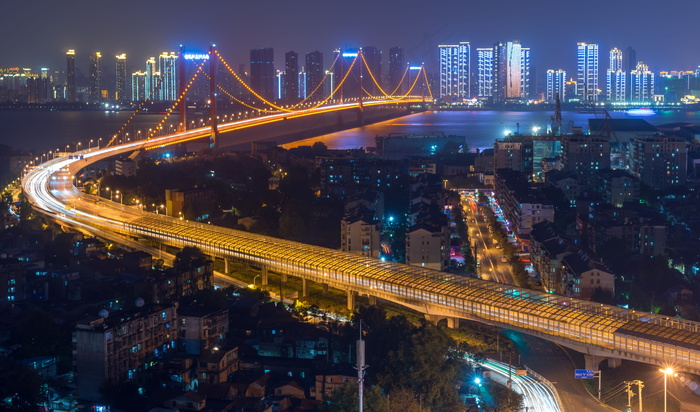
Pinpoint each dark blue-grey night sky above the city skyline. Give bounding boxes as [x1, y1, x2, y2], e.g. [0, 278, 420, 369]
[0, 0, 700, 77]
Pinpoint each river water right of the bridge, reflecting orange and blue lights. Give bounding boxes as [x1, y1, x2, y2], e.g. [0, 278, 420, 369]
[283, 111, 700, 149]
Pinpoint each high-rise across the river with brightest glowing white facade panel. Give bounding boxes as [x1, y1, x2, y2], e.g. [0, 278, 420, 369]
[492, 41, 530, 102]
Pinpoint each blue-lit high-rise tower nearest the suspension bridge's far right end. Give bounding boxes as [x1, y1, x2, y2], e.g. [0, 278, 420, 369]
[438, 42, 471, 102]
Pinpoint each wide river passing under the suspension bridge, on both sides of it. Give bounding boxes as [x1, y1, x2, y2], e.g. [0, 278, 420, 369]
[0, 111, 700, 153]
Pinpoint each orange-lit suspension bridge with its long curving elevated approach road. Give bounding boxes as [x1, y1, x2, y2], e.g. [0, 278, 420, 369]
[17, 47, 700, 374]
